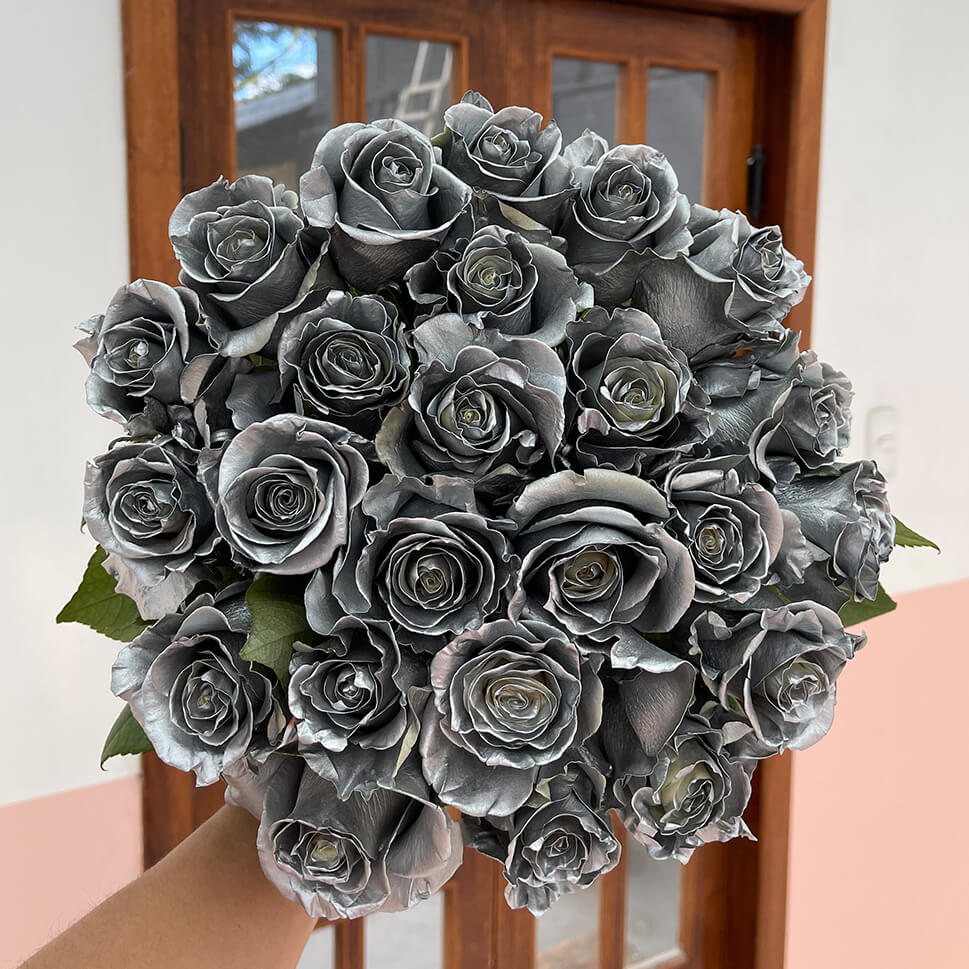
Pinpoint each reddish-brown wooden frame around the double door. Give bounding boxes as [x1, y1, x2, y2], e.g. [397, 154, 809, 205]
[121, 0, 827, 969]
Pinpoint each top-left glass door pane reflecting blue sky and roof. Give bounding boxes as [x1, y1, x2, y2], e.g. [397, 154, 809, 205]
[232, 20, 336, 189]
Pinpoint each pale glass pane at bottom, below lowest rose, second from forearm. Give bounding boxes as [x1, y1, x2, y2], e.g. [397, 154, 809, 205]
[364, 892, 444, 969]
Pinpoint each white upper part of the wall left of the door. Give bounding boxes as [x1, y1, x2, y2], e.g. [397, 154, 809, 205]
[0, 0, 137, 805]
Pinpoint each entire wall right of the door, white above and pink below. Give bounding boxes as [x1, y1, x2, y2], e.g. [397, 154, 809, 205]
[785, 0, 969, 969]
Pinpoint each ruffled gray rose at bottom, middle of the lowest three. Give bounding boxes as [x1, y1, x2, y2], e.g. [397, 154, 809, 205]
[475, 763, 622, 915]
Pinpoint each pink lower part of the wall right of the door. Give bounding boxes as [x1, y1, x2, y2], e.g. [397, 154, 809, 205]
[785, 581, 969, 969]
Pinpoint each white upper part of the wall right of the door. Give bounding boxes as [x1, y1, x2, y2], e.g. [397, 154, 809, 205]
[813, 0, 969, 592]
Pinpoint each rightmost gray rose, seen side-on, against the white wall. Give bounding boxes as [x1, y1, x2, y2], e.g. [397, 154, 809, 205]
[775, 461, 895, 599]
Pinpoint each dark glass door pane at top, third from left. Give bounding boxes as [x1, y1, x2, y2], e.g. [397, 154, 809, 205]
[552, 57, 619, 145]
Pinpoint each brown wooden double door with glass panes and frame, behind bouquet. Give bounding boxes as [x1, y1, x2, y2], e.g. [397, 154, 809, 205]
[124, 0, 825, 969]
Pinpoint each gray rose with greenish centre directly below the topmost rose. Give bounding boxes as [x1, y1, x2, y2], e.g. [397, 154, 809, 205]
[405, 225, 592, 347]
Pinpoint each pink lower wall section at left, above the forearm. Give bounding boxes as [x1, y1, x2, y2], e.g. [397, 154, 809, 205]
[0, 777, 141, 969]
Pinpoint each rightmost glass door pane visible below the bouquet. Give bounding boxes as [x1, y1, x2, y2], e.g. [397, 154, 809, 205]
[626, 838, 682, 969]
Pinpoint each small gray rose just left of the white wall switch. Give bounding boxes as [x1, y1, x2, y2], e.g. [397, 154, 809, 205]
[767, 350, 854, 478]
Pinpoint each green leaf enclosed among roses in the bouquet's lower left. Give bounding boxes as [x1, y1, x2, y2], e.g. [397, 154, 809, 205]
[239, 575, 313, 686]
